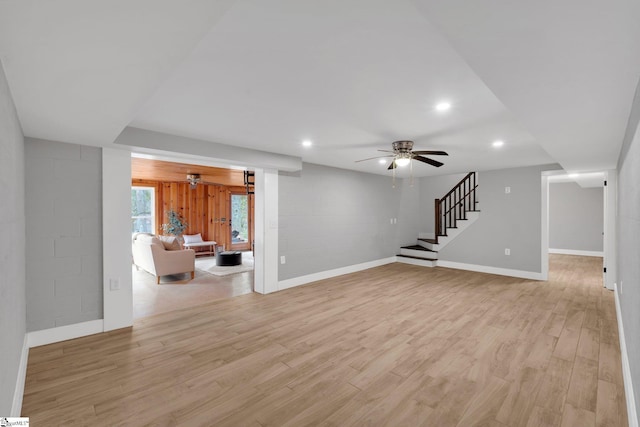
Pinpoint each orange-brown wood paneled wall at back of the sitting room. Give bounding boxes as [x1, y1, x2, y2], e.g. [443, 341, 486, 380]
[131, 179, 255, 250]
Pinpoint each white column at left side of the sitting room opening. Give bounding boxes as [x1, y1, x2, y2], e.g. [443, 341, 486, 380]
[102, 148, 133, 331]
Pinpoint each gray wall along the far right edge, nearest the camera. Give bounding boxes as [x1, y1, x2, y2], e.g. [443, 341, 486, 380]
[617, 88, 640, 421]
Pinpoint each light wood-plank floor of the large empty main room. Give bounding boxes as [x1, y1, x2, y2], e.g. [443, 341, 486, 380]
[22, 255, 627, 427]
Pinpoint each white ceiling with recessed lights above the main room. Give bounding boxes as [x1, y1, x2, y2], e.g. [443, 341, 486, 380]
[0, 0, 640, 176]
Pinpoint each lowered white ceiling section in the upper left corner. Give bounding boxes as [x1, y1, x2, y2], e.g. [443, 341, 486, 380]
[0, 0, 232, 145]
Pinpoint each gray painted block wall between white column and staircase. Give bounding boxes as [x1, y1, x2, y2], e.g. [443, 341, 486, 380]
[278, 163, 401, 280]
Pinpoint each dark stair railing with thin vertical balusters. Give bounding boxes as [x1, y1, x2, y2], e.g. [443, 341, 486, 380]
[435, 172, 478, 243]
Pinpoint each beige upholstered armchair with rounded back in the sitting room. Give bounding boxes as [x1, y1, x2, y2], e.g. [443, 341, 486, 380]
[132, 233, 196, 284]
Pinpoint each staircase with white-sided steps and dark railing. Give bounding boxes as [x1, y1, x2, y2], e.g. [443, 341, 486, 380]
[397, 172, 480, 267]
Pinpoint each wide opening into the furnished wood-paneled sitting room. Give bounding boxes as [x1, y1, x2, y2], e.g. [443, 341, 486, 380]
[131, 154, 254, 319]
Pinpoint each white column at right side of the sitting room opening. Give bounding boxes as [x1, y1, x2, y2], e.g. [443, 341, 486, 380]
[254, 169, 278, 294]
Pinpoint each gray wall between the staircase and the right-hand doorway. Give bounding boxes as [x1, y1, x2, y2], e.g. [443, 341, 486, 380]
[438, 165, 557, 273]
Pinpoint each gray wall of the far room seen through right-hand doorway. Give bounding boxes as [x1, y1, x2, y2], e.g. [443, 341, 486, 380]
[549, 182, 604, 252]
